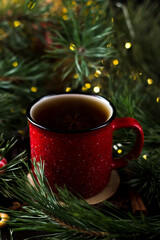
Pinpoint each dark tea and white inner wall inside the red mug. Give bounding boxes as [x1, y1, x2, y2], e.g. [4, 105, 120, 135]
[31, 94, 111, 132]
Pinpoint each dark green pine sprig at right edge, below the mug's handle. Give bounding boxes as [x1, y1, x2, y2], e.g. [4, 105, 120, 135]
[127, 151, 160, 208]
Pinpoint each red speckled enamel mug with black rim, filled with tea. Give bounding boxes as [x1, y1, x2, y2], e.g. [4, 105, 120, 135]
[27, 93, 144, 198]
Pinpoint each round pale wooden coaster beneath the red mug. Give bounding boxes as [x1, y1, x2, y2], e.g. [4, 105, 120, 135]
[27, 170, 120, 205]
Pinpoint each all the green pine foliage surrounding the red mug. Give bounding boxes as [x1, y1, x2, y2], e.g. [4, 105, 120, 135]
[0, 0, 160, 240]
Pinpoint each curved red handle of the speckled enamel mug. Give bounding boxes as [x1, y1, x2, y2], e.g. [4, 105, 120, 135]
[111, 117, 144, 169]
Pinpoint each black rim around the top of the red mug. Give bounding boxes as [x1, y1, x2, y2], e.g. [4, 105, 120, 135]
[26, 93, 116, 134]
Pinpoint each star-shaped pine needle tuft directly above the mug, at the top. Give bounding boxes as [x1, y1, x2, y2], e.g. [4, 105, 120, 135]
[47, 1, 113, 88]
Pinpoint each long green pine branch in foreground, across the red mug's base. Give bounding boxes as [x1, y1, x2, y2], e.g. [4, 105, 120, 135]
[1, 159, 160, 239]
